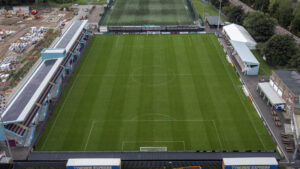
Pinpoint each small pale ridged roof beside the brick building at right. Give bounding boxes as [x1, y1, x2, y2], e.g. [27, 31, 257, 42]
[258, 82, 285, 105]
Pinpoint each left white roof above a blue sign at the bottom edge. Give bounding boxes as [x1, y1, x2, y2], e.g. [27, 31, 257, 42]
[67, 158, 121, 167]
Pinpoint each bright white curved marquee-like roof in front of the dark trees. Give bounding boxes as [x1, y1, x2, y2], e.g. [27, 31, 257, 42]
[223, 24, 257, 46]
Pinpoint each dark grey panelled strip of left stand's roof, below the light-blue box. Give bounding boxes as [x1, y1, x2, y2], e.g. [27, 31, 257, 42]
[3, 59, 56, 121]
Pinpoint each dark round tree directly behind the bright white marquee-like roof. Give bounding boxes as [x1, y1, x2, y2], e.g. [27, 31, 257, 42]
[226, 6, 245, 25]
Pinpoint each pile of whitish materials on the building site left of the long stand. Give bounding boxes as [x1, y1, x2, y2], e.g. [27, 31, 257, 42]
[9, 27, 47, 53]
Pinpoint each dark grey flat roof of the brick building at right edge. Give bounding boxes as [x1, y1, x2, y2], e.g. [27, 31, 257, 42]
[274, 70, 300, 95]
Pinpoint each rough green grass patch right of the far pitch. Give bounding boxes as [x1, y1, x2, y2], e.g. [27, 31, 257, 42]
[192, 0, 226, 22]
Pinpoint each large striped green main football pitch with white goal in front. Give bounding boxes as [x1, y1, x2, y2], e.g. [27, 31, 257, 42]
[37, 34, 275, 151]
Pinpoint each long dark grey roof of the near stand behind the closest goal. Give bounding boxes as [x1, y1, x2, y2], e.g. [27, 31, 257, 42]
[28, 151, 278, 162]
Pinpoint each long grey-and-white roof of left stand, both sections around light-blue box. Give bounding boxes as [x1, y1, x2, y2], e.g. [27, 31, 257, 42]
[1, 21, 87, 123]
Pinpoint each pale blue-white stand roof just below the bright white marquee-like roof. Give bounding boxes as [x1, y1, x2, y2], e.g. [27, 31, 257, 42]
[230, 40, 259, 65]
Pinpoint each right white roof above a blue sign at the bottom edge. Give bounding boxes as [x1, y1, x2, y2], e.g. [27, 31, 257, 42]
[223, 157, 278, 165]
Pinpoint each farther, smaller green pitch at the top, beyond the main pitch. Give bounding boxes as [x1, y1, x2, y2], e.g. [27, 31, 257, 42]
[101, 0, 193, 26]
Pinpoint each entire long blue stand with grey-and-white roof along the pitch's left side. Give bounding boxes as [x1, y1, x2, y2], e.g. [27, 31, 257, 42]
[1, 21, 90, 146]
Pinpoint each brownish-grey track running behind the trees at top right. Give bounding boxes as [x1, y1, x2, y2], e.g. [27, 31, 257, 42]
[229, 0, 300, 45]
